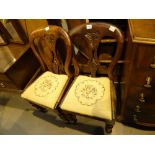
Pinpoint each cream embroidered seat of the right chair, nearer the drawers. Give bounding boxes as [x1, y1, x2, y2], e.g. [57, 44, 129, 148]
[60, 75, 112, 120]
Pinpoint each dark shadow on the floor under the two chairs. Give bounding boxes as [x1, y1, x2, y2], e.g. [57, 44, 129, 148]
[33, 111, 104, 135]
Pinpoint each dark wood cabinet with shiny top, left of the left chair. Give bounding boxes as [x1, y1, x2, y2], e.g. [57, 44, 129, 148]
[0, 44, 40, 91]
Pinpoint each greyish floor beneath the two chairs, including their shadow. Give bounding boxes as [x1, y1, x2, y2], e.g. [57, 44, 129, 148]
[0, 92, 155, 135]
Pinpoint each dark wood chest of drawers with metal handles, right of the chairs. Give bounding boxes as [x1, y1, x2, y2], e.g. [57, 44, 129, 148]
[121, 19, 155, 127]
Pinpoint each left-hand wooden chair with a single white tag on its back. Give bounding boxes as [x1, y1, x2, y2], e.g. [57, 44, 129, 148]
[21, 26, 73, 121]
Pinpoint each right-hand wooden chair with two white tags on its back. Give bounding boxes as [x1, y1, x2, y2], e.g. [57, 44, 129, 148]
[60, 23, 124, 133]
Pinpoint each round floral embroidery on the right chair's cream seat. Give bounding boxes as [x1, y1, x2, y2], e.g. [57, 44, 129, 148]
[75, 80, 105, 106]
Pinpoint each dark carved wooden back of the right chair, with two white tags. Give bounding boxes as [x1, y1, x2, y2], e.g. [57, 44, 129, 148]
[69, 22, 124, 79]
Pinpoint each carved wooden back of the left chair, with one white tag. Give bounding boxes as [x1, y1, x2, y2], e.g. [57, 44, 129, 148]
[30, 25, 72, 77]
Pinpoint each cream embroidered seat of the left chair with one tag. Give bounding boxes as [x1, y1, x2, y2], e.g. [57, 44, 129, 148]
[21, 71, 68, 109]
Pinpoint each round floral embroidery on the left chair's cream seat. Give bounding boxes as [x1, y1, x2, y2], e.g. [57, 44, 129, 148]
[34, 75, 59, 97]
